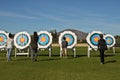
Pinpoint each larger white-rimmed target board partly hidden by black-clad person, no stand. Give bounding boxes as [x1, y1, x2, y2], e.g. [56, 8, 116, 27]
[86, 31, 103, 48]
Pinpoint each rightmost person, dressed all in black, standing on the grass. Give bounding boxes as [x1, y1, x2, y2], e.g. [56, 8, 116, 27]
[98, 34, 107, 64]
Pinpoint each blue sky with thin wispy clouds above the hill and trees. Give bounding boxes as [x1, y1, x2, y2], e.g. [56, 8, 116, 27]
[0, 0, 120, 35]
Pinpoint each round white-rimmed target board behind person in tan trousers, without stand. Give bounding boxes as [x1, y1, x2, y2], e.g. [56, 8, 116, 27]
[59, 31, 77, 48]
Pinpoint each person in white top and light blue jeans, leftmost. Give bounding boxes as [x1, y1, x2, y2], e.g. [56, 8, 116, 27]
[6, 33, 13, 61]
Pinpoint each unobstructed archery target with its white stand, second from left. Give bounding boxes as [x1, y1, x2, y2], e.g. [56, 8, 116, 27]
[14, 31, 31, 57]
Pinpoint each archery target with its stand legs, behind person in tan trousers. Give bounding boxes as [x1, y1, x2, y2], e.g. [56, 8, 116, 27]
[59, 31, 77, 57]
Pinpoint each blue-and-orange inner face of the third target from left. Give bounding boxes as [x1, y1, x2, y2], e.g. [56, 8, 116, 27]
[38, 33, 50, 46]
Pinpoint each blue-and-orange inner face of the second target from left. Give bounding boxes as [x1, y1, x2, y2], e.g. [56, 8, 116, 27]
[16, 34, 29, 46]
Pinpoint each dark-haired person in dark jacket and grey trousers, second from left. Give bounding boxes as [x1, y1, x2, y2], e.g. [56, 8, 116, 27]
[30, 32, 38, 61]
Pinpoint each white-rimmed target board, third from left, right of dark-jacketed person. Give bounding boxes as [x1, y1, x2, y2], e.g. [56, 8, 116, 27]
[38, 31, 52, 48]
